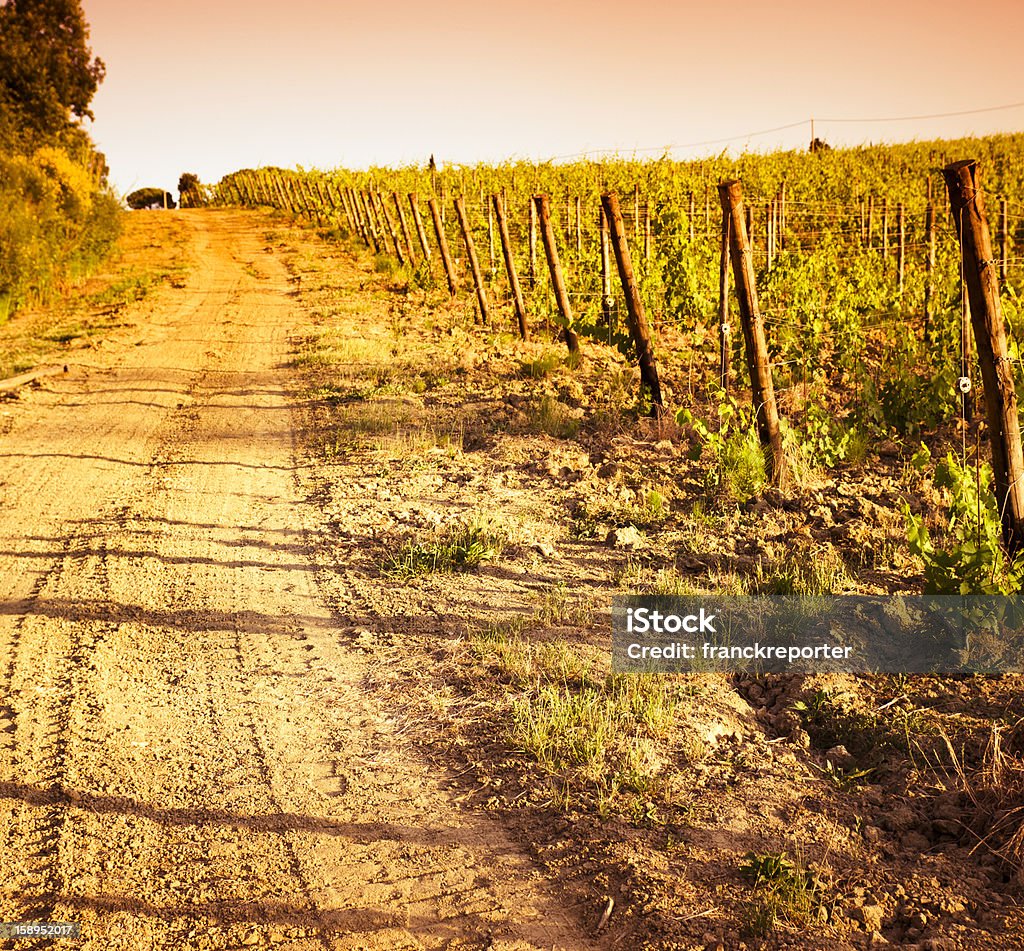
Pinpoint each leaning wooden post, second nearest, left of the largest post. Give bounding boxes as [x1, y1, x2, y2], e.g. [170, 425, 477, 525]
[718, 180, 788, 486]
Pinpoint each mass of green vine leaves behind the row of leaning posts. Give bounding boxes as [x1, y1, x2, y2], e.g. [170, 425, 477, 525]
[216, 136, 1024, 446]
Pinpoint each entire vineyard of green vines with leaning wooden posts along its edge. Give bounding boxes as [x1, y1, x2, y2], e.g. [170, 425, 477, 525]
[213, 136, 1024, 594]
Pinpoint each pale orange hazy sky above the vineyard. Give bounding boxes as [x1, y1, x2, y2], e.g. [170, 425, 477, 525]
[82, 0, 1024, 193]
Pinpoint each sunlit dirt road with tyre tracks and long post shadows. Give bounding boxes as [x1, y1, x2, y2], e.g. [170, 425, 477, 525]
[0, 212, 592, 949]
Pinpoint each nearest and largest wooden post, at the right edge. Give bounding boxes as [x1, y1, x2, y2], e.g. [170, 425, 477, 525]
[942, 159, 1024, 554]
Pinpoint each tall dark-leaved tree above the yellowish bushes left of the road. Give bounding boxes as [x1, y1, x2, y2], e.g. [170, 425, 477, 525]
[0, 0, 105, 147]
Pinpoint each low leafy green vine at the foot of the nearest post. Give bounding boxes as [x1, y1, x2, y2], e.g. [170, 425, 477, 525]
[904, 452, 1024, 595]
